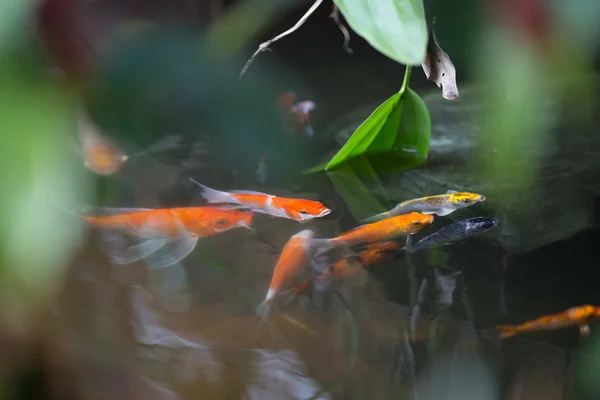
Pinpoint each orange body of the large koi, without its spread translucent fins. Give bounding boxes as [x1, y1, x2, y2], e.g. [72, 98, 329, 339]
[82, 207, 253, 238]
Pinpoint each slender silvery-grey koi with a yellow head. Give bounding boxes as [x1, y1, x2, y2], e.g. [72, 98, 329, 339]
[362, 190, 485, 223]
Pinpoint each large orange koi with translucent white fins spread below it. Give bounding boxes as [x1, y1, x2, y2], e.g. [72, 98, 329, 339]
[81, 207, 253, 268]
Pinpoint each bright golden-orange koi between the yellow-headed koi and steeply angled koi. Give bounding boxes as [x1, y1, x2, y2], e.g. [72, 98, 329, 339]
[311, 212, 433, 256]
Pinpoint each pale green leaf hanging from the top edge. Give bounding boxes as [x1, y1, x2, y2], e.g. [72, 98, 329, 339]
[334, 0, 428, 65]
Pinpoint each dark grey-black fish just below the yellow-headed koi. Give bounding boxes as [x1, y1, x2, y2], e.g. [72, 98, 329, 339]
[404, 217, 498, 253]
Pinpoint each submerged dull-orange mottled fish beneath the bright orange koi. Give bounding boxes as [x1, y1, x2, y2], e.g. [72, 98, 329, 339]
[291, 242, 400, 293]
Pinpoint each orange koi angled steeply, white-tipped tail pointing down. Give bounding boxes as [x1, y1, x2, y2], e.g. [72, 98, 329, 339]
[256, 229, 314, 318]
